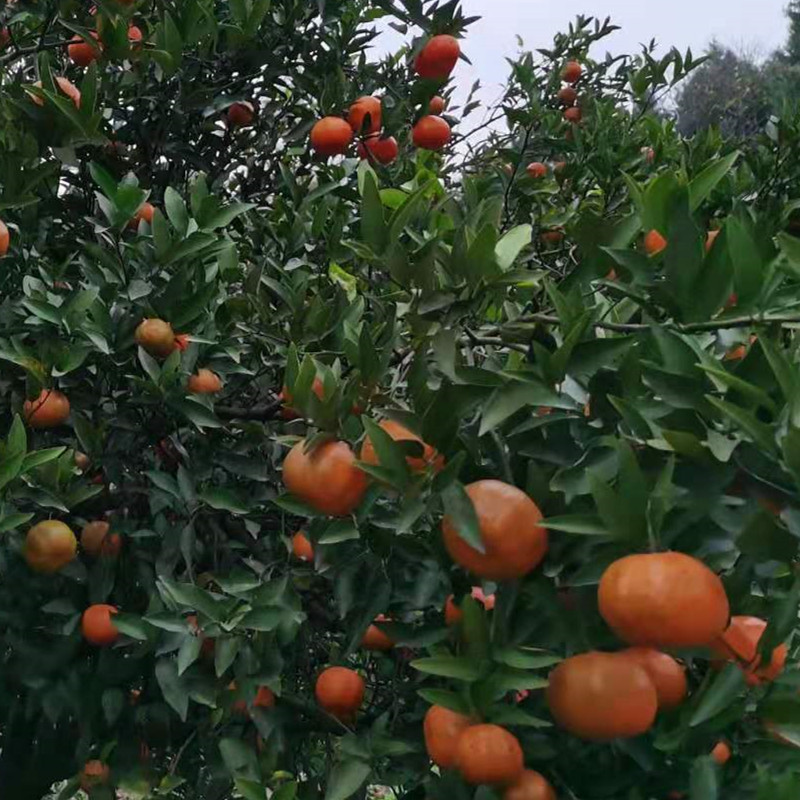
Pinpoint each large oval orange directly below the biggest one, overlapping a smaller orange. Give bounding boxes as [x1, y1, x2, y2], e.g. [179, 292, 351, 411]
[547, 652, 658, 741]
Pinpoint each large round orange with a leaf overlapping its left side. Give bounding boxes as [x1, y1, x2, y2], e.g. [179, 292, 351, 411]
[442, 480, 547, 581]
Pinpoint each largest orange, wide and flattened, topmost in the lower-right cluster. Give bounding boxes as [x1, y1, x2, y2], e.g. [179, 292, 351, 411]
[598, 553, 730, 648]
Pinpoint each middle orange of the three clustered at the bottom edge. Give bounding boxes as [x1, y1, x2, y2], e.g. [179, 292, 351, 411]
[456, 724, 525, 786]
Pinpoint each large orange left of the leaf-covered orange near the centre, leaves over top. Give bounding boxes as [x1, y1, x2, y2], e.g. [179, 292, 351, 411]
[283, 440, 367, 517]
